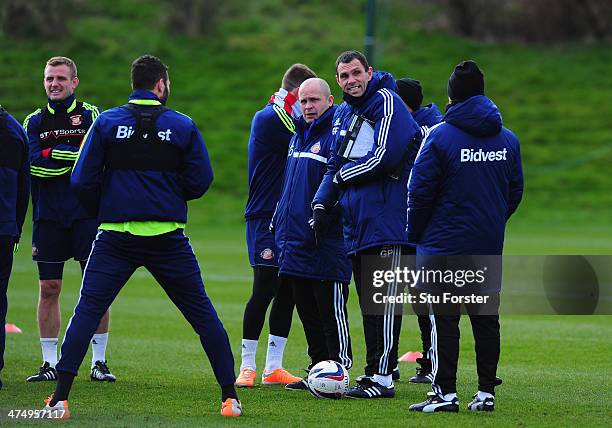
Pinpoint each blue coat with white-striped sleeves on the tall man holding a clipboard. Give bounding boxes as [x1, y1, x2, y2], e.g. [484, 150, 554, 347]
[313, 72, 420, 255]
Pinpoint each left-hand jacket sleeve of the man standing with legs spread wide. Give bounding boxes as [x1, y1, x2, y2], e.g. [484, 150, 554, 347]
[70, 120, 104, 216]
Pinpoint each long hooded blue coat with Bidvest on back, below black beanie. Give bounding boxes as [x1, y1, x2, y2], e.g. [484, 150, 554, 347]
[407, 95, 523, 255]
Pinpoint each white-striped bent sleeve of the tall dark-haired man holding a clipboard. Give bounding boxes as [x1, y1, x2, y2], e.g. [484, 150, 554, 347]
[340, 89, 419, 185]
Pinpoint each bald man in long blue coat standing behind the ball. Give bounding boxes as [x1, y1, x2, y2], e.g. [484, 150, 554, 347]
[272, 78, 353, 389]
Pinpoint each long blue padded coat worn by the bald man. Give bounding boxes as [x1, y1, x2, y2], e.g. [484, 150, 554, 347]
[272, 106, 351, 283]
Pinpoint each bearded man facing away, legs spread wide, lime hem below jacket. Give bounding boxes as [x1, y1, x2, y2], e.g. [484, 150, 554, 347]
[45, 55, 242, 417]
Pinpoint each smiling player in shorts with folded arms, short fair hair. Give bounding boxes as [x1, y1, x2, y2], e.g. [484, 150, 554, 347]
[23, 56, 115, 382]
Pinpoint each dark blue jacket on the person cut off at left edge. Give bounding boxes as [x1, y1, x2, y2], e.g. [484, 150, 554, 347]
[0, 107, 30, 241]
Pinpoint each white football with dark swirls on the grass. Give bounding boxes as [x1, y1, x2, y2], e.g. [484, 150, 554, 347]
[308, 360, 349, 400]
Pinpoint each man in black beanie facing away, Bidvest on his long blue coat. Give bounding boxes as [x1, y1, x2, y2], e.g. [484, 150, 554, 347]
[407, 61, 523, 413]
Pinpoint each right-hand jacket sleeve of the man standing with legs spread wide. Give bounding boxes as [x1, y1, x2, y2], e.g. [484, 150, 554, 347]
[180, 122, 213, 201]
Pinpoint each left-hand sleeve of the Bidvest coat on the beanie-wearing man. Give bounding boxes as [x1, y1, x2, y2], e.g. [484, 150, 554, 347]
[406, 135, 442, 244]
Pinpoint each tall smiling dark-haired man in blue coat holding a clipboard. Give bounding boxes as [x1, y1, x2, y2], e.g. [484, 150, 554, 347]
[313, 51, 420, 399]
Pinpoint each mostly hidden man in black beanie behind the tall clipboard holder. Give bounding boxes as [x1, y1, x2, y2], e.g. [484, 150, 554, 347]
[394, 77, 442, 383]
